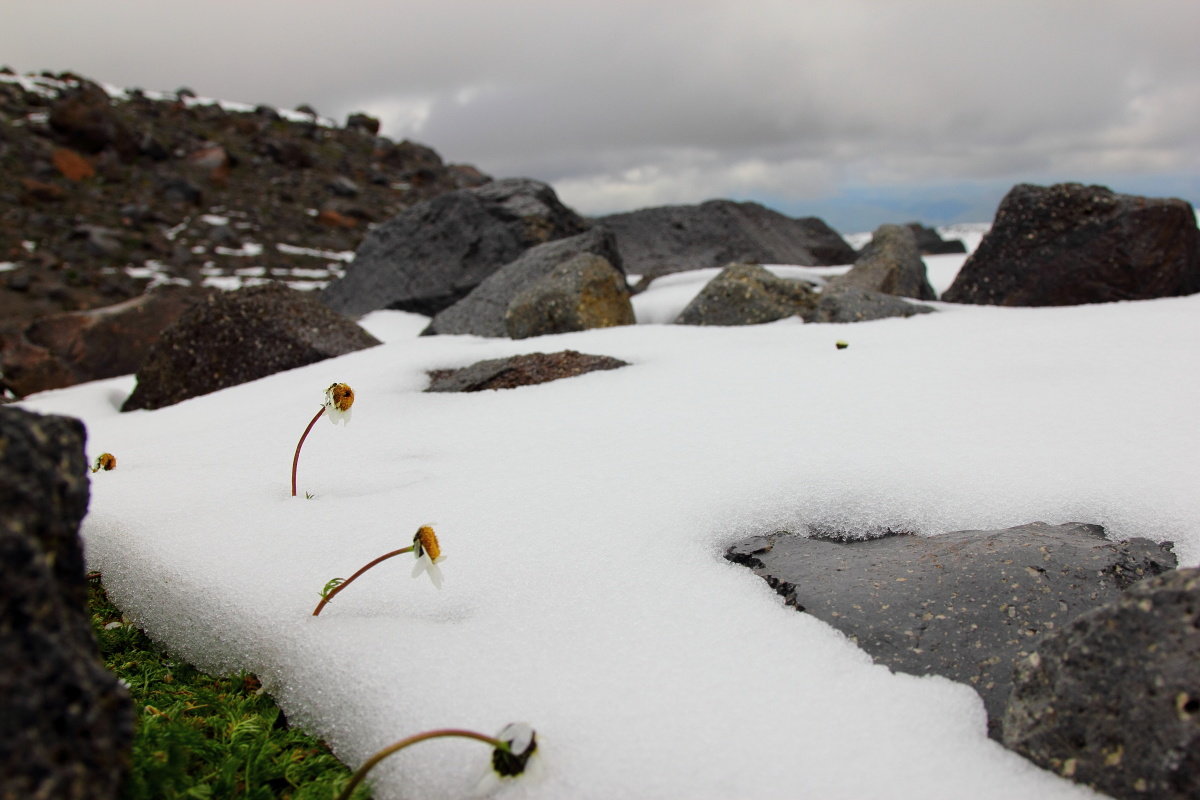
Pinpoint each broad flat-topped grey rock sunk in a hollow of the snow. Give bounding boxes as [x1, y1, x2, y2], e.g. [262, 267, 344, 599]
[726, 523, 1176, 738]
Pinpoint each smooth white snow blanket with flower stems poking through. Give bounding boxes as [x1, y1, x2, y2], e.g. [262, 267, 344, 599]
[23, 244, 1200, 800]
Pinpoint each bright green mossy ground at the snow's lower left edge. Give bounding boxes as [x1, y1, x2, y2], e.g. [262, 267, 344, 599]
[88, 578, 371, 800]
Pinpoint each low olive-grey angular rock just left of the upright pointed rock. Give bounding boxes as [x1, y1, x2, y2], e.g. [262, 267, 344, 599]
[676, 264, 817, 325]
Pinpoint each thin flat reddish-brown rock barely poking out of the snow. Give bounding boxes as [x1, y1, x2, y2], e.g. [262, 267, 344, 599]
[425, 350, 629, 392]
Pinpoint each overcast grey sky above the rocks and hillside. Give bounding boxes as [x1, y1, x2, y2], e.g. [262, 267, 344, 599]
[0, 0, 1200, 233]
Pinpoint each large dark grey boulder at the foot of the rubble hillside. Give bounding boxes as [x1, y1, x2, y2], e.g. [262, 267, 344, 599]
[320, 179, 588, 317]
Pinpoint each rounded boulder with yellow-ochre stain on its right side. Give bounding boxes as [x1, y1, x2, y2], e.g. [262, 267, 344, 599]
[504, 253, 636, 339]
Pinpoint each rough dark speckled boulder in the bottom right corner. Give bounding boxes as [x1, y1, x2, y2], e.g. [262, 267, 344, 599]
[1003, 569, 1200, 800]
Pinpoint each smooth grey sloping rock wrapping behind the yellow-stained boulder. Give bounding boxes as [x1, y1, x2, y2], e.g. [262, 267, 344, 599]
[422, 225, 622, 337]
